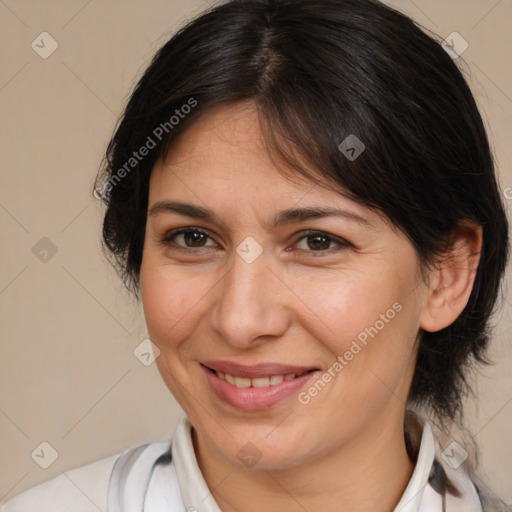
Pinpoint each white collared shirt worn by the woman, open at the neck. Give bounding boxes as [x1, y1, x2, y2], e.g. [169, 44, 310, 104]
[0, 411, 504, 512]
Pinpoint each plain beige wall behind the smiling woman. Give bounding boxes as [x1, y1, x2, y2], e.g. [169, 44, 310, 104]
[0, 0, 512, 503]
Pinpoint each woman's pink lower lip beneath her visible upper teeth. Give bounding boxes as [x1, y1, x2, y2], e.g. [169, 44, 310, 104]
[201, 365, 318, 411]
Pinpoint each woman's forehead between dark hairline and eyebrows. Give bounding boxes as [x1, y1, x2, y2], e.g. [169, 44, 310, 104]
[149, 102, 385, 231]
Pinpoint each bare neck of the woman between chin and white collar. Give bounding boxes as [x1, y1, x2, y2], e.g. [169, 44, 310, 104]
[193, 410, 414, 512]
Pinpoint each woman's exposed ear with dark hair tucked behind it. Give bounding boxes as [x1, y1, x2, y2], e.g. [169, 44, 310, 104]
[420, 221, 482, 332]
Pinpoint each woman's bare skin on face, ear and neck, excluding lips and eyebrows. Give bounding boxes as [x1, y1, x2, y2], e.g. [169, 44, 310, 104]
[140, 103, 481, 512]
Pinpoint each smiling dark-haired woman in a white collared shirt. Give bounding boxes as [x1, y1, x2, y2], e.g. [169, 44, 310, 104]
[3, 0, 512, 512]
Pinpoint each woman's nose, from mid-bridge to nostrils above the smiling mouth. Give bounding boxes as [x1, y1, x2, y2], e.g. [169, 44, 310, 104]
[211, 247, 291, 348]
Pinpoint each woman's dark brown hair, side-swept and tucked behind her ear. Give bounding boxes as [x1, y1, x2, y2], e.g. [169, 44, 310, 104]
[96, 0, 508, 420]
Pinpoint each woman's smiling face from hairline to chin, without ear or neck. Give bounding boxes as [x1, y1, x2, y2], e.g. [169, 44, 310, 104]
[140, 104, 427, 468]
